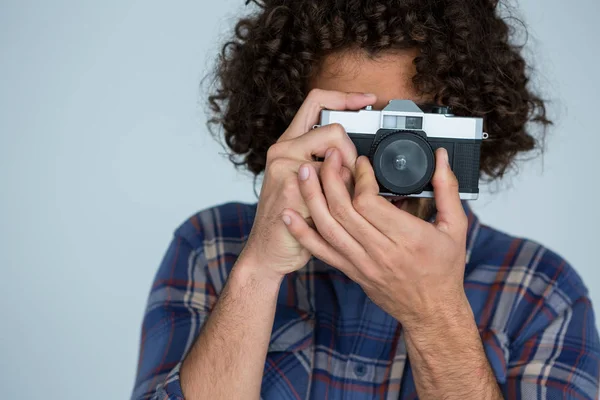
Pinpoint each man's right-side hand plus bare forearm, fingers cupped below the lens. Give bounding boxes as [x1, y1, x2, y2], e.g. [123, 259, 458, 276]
[283, 149, 502, 400]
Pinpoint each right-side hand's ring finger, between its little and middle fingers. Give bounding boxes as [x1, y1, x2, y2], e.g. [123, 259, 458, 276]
[298, 164, 367, 262]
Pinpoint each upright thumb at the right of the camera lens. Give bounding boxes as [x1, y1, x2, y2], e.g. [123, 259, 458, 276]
[431, 148, 467, 238]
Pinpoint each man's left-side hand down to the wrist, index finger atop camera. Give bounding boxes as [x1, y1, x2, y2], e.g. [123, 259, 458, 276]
[238, 89, 376, 279]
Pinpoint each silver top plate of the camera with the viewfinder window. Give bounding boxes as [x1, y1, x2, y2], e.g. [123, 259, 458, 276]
[319, 100, 487, 140]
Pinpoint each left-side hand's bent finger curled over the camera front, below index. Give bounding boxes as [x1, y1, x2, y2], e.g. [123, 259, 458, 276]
[277, 124, 357, 171]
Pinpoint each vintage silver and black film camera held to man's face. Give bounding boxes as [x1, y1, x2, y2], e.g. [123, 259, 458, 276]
[319, 100, 487, 200]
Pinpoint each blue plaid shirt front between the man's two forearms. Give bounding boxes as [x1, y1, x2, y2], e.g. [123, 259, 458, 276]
[261, 280, 414, 399]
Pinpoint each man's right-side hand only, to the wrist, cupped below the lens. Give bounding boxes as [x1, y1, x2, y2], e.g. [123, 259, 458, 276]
[284, 149, 468, 330]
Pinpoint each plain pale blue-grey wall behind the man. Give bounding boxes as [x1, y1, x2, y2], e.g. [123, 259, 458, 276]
[0, 0, 600, 399]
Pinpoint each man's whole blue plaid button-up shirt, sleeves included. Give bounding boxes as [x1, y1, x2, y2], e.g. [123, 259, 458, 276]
[132, 203, 600, 399]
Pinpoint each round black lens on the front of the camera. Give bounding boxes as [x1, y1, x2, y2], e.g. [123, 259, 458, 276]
[373, 132, 434, 195]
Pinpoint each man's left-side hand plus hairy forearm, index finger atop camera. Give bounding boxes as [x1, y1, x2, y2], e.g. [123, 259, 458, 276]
[180, 90, 376, 399]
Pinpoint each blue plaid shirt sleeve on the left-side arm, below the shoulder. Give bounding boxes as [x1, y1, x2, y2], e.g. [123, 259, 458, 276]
[132, 234, 217, 400]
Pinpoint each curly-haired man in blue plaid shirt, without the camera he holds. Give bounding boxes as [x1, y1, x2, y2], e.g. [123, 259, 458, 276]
[133, 0, 600, 399]
